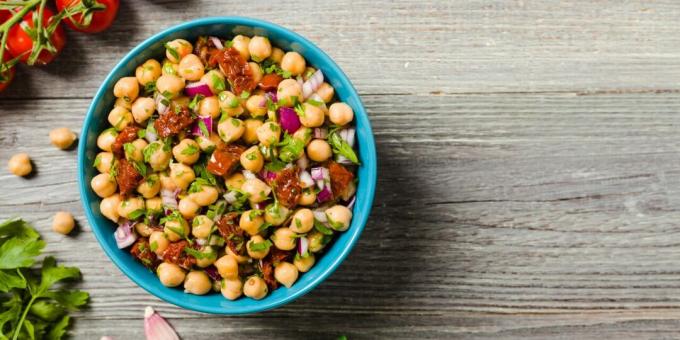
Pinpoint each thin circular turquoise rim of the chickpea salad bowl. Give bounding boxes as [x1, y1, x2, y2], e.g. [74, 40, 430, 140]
[78, 16, 378, 315]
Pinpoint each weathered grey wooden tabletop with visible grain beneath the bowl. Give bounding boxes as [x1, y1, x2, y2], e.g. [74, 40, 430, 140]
[0, 0, 680, 339]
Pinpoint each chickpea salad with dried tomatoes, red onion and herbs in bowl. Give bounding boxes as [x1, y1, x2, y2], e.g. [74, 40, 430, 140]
[90, 35, 359, 300]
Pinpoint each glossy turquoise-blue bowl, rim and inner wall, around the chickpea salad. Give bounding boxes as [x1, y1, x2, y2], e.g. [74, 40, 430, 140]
[78, 17, 377, 314]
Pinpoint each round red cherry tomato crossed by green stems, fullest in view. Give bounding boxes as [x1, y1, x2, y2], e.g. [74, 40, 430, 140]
[7, 8, 66, 65]
